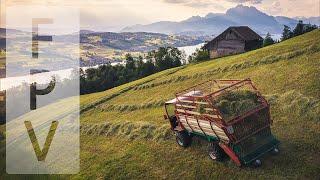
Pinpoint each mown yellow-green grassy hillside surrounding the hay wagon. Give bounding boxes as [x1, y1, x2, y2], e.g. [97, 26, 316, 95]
[1, 30, 320, 179]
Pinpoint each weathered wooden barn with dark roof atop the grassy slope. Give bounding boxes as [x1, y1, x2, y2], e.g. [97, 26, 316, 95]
[203, 26, 263, 58]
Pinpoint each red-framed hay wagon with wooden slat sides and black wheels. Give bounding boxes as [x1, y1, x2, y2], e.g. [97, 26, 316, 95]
[165, 79, 279, 166]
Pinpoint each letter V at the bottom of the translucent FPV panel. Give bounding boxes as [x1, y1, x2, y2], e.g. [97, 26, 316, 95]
[24, 121, 58, 161]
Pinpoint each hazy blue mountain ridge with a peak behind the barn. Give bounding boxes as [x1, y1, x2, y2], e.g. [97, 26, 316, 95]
[121, 5, 320, 35]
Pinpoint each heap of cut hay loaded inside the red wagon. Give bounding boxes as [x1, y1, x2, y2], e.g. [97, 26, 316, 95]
[213, 90, 260, 122]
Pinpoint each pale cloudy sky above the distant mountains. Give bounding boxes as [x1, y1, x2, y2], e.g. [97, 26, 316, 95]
[0, 0, 320, 31]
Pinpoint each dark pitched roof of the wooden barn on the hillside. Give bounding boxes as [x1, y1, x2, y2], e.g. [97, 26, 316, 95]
[204, 26, 263, 48]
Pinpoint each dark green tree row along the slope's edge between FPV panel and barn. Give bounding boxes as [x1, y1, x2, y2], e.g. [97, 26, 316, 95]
[80, 47, 184, 94]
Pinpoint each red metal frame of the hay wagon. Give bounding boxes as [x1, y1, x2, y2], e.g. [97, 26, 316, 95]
[166, 79, 272, 166]
